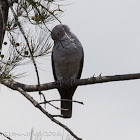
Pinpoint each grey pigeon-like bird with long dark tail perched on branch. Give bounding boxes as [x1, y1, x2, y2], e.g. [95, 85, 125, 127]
[51, 24, 84, 118]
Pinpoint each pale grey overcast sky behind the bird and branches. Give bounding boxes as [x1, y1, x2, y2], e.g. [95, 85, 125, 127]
[0, 0, 140, 140]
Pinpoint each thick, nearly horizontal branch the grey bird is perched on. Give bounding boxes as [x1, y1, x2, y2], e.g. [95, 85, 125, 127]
[0, 73, 140, 92]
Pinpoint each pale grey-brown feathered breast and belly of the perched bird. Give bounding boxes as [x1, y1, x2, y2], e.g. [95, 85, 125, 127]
[53, 44, 82, 81]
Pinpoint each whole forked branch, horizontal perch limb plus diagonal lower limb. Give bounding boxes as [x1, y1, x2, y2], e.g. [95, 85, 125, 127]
[0, 73, 140, 140]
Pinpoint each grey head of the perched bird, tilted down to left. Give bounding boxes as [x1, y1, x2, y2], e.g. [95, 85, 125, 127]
[51, 24, 70, 42]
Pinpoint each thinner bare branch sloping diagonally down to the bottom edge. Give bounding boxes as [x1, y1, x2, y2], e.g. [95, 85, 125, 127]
[3, 81, 82, 140]
